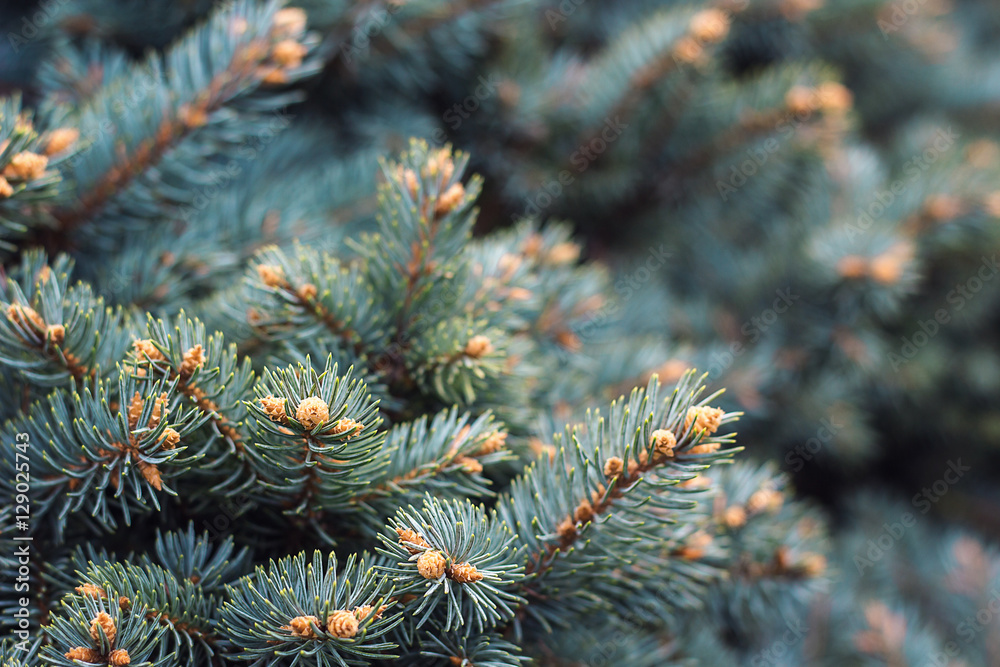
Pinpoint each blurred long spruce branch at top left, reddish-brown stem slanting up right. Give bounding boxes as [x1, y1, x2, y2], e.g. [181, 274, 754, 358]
[51, 0, 315, 239]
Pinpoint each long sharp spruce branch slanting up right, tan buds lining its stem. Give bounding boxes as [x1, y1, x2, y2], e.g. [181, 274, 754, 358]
[497, 371, 738, 627]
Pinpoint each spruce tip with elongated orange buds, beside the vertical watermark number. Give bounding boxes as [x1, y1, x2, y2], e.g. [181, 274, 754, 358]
[5, 366, 212, 532]
